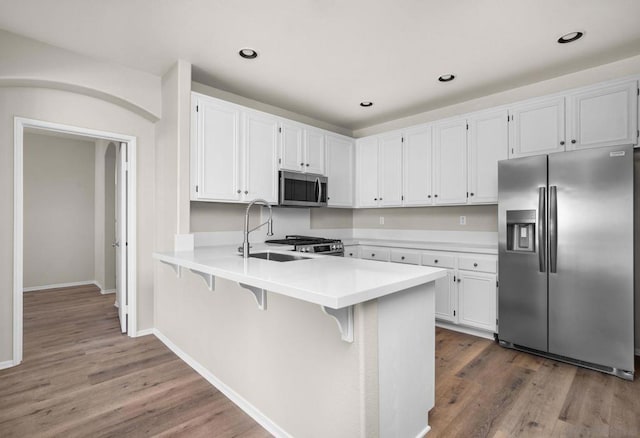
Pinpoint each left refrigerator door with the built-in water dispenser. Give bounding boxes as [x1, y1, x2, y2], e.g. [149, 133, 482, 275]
[498, 155, 547, 351]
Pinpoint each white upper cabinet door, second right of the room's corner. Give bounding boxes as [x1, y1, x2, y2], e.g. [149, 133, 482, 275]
[378, 134, 402, 207]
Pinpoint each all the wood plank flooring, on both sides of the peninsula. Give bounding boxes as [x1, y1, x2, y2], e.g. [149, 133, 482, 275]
[0, 286, 640, 438]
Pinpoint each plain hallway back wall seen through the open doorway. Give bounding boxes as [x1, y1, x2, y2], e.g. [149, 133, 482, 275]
[24, 133, 95, 288]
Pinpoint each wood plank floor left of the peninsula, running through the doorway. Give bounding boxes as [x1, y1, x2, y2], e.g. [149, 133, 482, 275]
[0, 286, 270, 438]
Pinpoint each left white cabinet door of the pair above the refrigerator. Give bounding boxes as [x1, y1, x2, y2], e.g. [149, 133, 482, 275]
[509, 97, 564, 158]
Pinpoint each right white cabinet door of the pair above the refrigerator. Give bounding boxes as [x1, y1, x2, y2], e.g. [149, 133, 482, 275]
[567, 81, 638, 150]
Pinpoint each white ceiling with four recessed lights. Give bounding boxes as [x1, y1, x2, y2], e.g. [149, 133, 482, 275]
[0, 0, 640, 130]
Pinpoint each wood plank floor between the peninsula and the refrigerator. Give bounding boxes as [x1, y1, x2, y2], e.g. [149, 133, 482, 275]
[427, 328, 640, 438]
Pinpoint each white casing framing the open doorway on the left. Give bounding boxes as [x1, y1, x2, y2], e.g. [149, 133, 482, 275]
[13, 117, 138, 365]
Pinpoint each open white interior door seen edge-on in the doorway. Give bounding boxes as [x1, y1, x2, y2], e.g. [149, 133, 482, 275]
[114, 143, 128, 333]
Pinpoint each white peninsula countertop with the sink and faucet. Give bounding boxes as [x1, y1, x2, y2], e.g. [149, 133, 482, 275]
[153, 245, 446, 309]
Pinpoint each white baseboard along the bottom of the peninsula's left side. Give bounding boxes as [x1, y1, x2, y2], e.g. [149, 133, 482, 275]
[152, 329, 292, 438]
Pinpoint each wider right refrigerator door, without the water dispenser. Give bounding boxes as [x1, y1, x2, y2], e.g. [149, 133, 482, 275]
[549, 146, 634, 371]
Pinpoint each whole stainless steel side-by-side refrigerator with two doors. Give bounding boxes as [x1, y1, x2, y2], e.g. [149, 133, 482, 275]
[498, 146, 634, 380]
